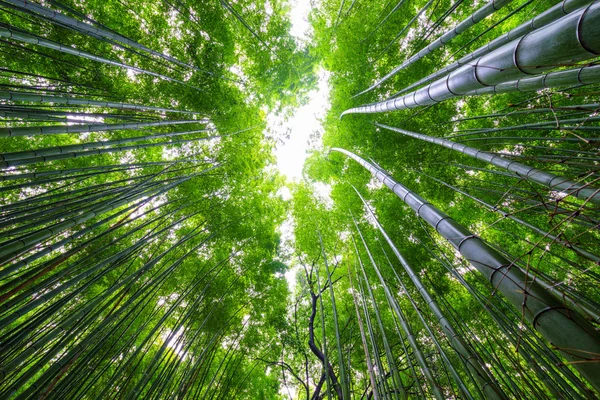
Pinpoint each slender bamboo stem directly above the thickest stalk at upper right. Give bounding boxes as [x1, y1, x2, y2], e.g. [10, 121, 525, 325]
[396, 0, 592, 95]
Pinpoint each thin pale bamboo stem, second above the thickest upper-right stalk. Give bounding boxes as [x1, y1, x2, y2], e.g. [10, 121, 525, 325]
[354, 0, 512, 97]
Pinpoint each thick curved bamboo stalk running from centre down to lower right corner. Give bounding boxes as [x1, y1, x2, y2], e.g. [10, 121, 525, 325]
[331, 149, 600, 388]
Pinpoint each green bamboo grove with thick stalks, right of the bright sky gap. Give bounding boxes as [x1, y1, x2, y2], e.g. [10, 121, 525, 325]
[290, 1, 600, 399]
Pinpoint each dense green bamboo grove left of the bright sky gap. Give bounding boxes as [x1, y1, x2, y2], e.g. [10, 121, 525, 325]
[0, 0, 314, 399]
